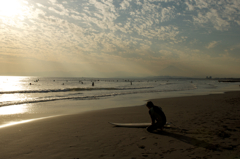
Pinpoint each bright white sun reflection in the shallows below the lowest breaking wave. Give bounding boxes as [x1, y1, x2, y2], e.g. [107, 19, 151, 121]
[0, 105, 28, 115]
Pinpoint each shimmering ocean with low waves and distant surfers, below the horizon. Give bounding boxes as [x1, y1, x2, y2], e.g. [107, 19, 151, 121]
[0, 76, 239, 124]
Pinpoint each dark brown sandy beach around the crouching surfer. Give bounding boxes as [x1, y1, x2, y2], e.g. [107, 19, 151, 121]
[0, 91, 240, 159]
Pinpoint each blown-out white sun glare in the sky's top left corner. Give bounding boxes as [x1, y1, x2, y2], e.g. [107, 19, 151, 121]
[0, 0, 23, 17]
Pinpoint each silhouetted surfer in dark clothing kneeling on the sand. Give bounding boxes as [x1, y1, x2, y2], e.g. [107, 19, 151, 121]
[146, 101, 167, 132]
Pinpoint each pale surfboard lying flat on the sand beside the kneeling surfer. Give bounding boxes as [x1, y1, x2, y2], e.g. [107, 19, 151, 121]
[109, 122, 171, 128]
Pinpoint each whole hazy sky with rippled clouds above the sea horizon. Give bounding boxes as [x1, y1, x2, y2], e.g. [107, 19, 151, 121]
[0, 0, 240, 78]
